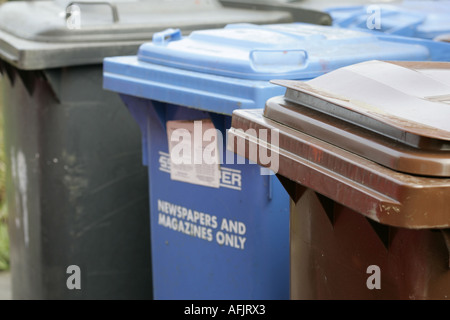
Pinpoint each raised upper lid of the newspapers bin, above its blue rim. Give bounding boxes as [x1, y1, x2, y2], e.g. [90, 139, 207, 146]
[138, 23, 446, 80]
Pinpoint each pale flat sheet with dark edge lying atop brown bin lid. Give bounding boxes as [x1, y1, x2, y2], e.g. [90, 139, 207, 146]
[274, 61, 450, 150]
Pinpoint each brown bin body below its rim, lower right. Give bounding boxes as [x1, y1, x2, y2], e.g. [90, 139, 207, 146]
[291, 189, 450, 300]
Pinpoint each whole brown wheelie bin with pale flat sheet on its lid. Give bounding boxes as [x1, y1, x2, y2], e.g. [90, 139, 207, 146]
[229, 61, 450, 299]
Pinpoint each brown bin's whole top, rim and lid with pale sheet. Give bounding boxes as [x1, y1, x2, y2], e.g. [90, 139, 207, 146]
[228, 61, 450, 229]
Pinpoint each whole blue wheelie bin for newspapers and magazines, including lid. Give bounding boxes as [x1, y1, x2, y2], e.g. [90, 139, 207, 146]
[103, 23, 450, 300]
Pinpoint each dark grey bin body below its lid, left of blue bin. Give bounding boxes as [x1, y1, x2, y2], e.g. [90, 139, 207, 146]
[2, 65, 152, 299]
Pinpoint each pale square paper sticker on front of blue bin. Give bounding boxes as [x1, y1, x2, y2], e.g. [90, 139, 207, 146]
[167, 119, 222, 188]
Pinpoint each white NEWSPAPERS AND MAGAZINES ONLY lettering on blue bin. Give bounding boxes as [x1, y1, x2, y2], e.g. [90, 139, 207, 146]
[158, 199, 247, 250]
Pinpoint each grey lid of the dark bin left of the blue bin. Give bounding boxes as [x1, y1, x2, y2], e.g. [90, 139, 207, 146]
[0, 0, 292, 70]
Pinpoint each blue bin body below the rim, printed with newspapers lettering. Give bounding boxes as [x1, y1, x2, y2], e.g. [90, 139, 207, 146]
[118, 96, 289, 300]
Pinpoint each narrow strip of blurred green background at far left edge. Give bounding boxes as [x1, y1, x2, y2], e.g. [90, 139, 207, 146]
[0, 0, 9, 271]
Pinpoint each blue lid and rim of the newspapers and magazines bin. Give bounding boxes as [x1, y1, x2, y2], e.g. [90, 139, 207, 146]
[104, 23, 450, 115]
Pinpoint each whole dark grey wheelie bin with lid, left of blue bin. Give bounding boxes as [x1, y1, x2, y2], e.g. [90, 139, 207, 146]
[0, 1, 291, 299]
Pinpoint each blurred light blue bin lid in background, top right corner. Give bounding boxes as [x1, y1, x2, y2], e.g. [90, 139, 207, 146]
[324, 0, 450, 39]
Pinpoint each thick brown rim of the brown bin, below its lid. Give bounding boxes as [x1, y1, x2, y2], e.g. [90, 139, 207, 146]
[228, 109, 450, 229]
